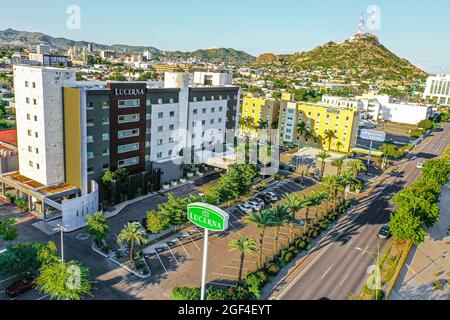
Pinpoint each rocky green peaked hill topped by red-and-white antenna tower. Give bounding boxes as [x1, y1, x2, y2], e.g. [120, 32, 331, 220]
[282, 35, 427, 81]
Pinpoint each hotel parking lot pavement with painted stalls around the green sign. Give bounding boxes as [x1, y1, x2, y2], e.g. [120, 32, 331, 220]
[140, 180, 312, 287]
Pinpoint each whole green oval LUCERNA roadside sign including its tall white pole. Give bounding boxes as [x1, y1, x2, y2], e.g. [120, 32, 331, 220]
[187, 203, 229, 300]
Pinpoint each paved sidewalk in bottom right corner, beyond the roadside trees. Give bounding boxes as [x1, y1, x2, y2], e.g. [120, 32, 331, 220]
[389, 183, 450, 300]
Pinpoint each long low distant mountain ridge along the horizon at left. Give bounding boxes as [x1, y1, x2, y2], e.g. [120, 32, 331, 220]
[0, 29, 255, 64]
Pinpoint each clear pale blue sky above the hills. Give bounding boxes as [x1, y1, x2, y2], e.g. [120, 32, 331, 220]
[0, 0, 450, 73]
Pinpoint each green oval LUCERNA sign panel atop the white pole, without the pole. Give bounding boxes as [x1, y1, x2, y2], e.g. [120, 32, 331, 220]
[188, 203, 229, 231]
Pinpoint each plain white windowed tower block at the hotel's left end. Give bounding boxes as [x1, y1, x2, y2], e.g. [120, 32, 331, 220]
[14, 66, 76, 185]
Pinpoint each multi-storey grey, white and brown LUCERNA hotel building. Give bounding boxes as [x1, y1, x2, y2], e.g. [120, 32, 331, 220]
[0, 65, 240, 229]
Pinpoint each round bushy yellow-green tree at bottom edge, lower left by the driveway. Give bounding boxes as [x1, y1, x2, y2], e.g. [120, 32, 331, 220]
[35, 261, 92, 300]
